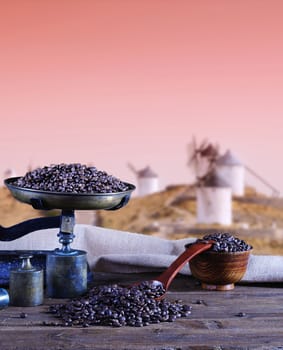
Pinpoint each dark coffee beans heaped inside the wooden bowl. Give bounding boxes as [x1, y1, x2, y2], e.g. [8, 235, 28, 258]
[197, 233, 252, 253]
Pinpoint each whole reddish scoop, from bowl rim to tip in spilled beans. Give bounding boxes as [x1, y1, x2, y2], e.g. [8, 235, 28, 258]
[134, 241, 214, 300]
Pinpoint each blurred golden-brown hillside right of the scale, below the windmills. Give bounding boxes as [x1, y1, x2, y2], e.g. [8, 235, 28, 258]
[97, 185, 283, 254]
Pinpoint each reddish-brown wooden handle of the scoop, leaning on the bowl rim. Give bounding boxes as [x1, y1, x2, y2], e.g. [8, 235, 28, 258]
[156, 241, 214, 290]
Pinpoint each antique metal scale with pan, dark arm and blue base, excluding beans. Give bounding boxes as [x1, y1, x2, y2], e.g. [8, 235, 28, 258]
[0, 177, 135, 298]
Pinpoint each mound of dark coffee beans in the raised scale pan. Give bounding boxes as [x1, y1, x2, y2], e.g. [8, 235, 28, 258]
[13, 163, 128, 193]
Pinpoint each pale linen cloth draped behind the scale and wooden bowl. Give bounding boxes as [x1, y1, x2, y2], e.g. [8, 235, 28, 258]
[0, 224, 283, 282]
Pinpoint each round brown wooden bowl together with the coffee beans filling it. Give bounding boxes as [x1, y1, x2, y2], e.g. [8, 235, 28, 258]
[189, 233, 252, 291]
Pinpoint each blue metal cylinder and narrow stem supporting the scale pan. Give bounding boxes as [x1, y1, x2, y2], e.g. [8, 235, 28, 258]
[46, 210, 87, 298]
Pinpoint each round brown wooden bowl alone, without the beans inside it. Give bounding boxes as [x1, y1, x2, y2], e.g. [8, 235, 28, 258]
[189, 249, 252, 291]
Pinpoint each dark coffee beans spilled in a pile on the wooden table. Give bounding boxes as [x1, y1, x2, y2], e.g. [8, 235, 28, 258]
[49, 281, 191, 327]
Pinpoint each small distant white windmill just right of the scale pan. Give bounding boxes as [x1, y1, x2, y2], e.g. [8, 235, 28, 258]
[128, 163, 159, 196]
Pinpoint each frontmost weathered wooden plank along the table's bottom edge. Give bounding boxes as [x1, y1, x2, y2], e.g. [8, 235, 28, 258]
[1, 321, 283, 350]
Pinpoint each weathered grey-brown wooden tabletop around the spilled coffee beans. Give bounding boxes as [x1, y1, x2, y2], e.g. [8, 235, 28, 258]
[0, 274, 283, 350]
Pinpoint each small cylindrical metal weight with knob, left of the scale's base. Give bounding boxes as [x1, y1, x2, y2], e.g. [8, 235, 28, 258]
[9, 255, 44, 306]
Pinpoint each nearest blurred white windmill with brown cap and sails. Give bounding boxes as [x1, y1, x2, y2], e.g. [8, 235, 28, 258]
[188, 137, 232, 225]
